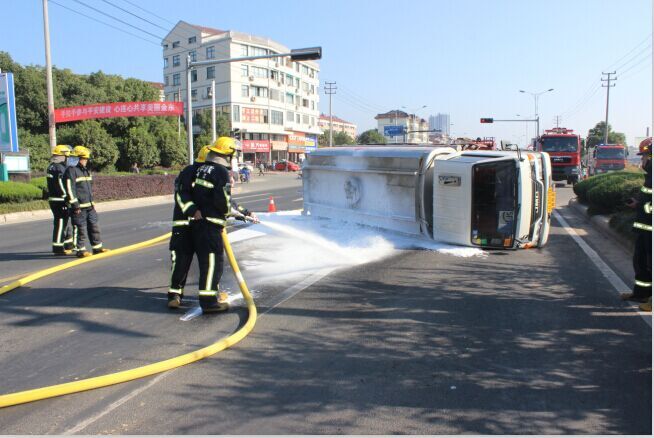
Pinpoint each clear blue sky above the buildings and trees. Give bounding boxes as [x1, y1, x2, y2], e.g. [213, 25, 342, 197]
[0, 0, 652, 144]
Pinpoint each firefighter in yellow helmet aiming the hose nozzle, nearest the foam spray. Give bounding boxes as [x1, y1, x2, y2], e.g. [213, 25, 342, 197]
[191, 137, 258, 313]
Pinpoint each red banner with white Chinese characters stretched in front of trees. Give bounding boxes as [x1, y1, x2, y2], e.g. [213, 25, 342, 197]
[55, 102, 184, 123]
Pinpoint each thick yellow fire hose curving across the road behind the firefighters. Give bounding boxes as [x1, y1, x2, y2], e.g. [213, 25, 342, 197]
[0, 228, 257, 408]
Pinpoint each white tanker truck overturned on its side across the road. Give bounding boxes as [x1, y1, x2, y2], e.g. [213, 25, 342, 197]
[302, 145, 555, 249]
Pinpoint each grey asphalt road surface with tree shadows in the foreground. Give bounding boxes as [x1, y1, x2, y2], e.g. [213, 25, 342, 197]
[0, 175, 652, 434]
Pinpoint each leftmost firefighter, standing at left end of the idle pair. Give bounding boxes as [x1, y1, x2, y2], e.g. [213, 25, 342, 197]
[46, 144, 73, 256]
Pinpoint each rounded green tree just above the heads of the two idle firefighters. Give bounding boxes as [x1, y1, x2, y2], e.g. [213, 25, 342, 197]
[57, 120, 118, 170]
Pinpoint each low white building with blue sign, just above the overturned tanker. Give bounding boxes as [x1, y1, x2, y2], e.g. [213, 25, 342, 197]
[375, 110, 429, 144]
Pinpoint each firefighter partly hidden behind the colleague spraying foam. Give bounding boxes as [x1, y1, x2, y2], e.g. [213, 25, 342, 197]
[168, 146, 209, 309]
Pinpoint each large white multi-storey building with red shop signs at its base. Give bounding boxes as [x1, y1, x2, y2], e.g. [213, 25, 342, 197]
[162, 21, 321, 162]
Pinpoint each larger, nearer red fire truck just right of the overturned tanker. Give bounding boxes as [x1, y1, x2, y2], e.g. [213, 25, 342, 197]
[536, 128, 581, 184]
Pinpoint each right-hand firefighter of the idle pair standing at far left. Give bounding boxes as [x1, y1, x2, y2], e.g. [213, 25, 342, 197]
[65, 146, 107, 258]
